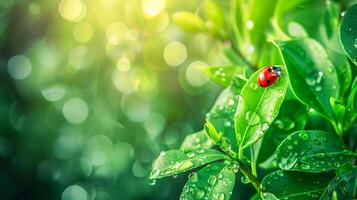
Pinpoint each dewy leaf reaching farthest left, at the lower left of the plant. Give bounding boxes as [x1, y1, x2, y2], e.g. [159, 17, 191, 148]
[150, 149, 226, 179]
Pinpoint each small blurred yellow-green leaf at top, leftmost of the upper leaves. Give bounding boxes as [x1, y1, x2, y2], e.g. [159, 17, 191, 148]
[172, 11, 205, 33]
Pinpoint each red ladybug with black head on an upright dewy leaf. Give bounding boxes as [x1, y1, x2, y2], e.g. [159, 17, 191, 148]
[258, 65, 283, 88]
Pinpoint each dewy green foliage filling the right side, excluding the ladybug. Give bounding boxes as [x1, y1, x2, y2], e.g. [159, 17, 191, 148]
[152, 0, 357, 200]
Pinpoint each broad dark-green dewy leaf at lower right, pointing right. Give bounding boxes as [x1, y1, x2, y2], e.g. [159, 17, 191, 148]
[276, 130, 352, 173]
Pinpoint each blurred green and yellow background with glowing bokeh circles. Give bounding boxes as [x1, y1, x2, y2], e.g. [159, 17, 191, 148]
[0, 0, 236, 200]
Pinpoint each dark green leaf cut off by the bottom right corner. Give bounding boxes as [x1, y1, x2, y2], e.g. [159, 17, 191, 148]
[321, 168, 357, 200]
